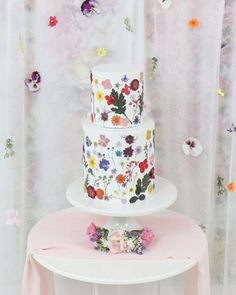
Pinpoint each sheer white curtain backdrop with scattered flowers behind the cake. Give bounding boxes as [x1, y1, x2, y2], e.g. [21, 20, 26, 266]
[0, 0, 236, 295]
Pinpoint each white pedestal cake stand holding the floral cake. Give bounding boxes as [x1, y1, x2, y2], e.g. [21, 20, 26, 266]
[66, 176, 177, 230]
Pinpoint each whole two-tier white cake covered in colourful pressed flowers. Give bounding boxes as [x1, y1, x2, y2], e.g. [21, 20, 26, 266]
[83, 64, 155, 204]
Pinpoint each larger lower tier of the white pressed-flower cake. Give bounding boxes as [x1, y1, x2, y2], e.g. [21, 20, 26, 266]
[83, 118, 155, 203]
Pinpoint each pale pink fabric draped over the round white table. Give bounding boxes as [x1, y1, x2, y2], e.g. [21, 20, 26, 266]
[21, 209, 210, 295]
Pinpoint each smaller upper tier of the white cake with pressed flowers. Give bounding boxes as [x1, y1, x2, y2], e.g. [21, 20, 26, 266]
[91, 64, 144, 128]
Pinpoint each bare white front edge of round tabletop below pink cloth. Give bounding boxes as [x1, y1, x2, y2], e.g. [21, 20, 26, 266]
[33, 254, 197, 285]
